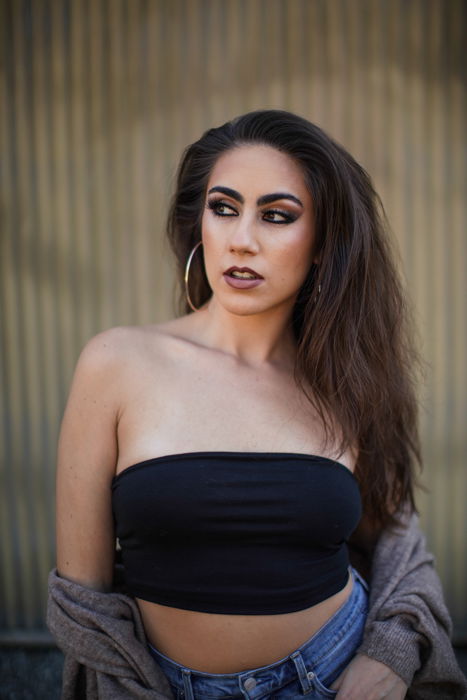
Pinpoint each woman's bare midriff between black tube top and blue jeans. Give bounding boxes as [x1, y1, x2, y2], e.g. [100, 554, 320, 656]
[137, 576, 353, 673]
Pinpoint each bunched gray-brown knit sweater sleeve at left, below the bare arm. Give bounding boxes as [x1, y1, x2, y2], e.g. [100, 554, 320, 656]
[47, 569, 173, 700]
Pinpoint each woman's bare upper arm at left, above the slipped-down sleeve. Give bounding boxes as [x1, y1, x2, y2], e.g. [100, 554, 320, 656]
[57, 331, 125, 590]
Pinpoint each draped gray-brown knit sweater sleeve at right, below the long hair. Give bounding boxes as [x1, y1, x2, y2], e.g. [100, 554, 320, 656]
[358, 515, 467, 700]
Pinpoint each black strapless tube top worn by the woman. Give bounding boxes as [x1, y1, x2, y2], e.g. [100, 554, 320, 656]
[112, 452, 361, 615]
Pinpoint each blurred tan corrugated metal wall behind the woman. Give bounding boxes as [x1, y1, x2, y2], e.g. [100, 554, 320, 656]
[0, 0, 467, 637]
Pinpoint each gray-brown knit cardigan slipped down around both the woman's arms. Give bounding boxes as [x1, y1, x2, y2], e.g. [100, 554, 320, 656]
[47, 516, 467, 700]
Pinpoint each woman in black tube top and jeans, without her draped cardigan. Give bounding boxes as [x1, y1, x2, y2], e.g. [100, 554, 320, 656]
[49, 111, 466, 700]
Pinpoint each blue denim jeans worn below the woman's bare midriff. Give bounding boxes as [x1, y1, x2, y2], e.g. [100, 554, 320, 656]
[149, 569, 368, 700]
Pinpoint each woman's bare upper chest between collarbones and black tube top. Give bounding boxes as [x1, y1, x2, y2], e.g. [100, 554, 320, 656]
[119, 346, 323, 468]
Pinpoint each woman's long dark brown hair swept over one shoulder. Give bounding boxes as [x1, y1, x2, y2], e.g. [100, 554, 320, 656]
[167, 110, 420, 526]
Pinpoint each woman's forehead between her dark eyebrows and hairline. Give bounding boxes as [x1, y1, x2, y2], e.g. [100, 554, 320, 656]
[208, 145, 307, 196]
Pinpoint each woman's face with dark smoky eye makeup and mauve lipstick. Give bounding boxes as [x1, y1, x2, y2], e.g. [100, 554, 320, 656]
[202, 145, 315, 315]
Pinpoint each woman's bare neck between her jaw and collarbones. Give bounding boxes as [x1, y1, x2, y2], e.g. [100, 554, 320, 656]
[196, 297, 296, 368]
